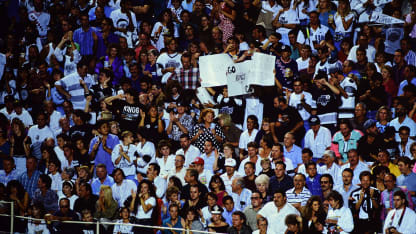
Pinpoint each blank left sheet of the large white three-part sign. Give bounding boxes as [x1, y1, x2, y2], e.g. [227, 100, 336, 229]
[199, 54, 234, 87]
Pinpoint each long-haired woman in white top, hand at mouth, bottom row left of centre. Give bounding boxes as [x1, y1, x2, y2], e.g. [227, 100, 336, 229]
[130, 180, 157, 234]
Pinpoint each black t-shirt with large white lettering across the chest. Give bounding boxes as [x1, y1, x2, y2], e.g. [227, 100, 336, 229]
[111, 100, 146, 131]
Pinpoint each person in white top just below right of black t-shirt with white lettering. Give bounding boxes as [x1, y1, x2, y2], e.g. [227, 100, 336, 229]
[136, 127, 156, 174]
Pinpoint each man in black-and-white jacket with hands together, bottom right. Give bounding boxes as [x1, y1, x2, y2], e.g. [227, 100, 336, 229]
[350, 171, 380, 233]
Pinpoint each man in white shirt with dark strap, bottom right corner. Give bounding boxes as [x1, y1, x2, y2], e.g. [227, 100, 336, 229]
[383, 190, 416, 234]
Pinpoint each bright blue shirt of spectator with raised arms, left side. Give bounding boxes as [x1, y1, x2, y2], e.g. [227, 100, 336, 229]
[88, 134, 120, 174]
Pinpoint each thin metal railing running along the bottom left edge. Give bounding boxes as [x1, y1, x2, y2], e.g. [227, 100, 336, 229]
[0, 201, 215, 234]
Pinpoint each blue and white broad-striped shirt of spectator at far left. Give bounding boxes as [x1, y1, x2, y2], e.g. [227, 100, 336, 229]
[55, 72, 92, 110]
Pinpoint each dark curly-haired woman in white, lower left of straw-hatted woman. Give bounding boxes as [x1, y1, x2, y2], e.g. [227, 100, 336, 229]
[156, 140, 175, 179]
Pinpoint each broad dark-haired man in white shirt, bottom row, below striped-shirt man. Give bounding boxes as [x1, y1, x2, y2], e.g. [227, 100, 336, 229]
[257, 190, 300, 234]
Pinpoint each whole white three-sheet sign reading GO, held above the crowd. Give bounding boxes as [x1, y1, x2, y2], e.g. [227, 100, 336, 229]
[199, 53, 276, 96]
